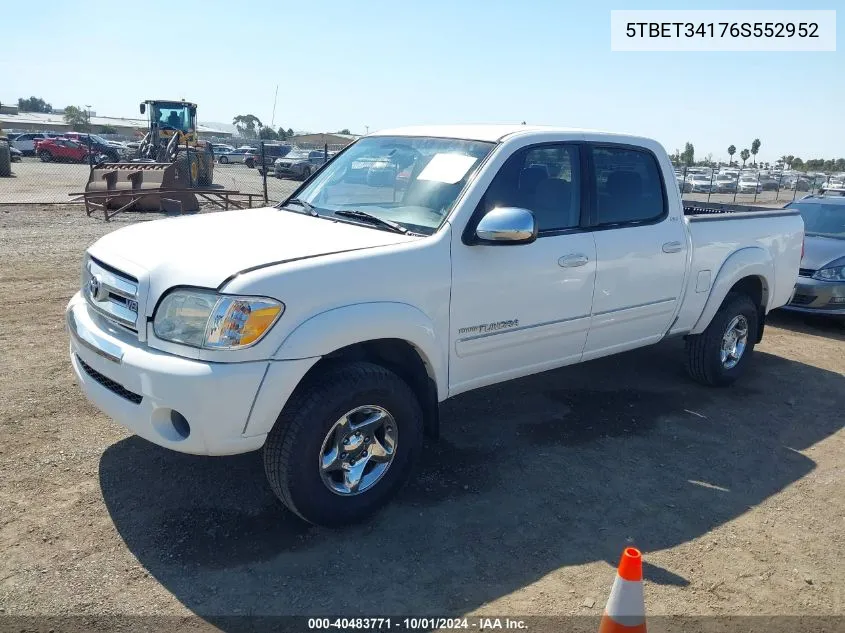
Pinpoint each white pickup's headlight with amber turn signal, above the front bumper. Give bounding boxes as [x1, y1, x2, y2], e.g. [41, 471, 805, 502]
[153, 290, 285, 349]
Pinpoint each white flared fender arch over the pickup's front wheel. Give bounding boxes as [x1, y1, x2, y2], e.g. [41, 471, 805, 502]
[274, 301, 449, 400]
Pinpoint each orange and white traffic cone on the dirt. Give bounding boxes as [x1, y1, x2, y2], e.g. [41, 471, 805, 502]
[599, 547, 646, 633]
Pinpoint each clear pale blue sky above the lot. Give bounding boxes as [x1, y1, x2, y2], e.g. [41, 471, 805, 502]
[0, 0, 845, 162]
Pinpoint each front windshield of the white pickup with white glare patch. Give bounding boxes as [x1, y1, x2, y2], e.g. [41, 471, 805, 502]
[285, 136, 494, 235]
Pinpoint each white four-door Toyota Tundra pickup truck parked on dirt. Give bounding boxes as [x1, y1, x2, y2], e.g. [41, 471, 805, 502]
[66, 126, 803, 525]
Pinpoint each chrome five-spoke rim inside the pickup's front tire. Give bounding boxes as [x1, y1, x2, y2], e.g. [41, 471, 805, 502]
[319, 405, 399, 495]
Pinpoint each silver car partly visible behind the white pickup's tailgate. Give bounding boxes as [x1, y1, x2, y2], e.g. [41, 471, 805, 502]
[784, 196, 845, 319]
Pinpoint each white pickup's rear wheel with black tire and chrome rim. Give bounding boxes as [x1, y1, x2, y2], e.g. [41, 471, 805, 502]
[686, 293, 760, 387]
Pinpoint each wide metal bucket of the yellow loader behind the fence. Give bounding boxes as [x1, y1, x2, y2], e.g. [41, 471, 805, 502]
[85, 160, 199, 213]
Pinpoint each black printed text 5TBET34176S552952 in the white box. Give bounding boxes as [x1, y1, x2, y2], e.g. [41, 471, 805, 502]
[625, 22, 819, 38]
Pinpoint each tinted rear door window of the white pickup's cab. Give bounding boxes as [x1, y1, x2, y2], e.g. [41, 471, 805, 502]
[591, 145, 666, 226]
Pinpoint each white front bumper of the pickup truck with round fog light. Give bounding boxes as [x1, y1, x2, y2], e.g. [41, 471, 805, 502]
[66, 293, 316, 455]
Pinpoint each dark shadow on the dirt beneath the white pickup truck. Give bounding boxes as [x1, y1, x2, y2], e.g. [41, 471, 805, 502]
[100, 341, 845, 629]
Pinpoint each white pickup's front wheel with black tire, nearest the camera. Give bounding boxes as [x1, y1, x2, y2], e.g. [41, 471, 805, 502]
[264, 362, 423, 526]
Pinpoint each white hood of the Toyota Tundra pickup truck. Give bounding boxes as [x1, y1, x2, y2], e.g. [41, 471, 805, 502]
[88, 207, 420, 301]
